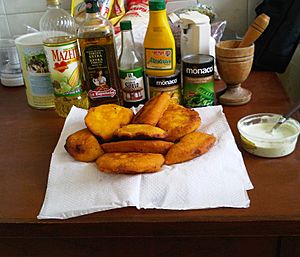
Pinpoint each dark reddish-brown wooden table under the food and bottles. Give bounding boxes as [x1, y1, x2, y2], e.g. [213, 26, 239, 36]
[0, 72, 300, 257]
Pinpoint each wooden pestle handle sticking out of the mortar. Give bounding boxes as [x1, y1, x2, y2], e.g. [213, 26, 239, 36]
[238, 13, 270, 47]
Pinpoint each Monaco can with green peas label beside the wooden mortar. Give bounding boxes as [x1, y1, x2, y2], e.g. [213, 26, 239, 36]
[182, 54, 215, 107]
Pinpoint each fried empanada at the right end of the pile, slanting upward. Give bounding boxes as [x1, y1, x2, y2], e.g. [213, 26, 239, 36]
[165, 132, 216, 165]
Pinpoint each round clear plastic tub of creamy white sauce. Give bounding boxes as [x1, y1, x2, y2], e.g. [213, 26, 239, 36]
[237, 113, 300, 158]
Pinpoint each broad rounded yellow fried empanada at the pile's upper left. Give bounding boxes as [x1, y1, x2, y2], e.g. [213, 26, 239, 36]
[84, 104, 133, 141]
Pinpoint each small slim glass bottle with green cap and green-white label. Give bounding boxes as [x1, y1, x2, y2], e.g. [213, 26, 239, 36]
[119, 21, 147, 107]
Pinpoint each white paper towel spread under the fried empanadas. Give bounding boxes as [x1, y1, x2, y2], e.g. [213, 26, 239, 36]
[38, 106, 253, 219]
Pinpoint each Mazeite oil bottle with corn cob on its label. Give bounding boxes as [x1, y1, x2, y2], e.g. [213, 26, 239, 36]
[40, 0, 89, 117]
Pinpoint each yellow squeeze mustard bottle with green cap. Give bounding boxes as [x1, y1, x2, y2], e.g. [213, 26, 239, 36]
[144, 0, 176, 77]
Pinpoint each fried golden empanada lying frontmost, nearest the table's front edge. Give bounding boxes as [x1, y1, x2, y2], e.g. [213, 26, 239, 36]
[96, 153, 165, 174]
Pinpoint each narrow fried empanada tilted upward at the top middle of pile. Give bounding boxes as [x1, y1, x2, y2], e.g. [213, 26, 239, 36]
[132, 92, 171, 126]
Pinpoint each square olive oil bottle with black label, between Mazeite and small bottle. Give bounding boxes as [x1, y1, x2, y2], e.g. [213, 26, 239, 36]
[77, 0, 122, 106]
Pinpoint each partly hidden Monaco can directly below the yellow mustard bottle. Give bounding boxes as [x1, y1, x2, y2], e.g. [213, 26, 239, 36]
[147, 70, 181, 104]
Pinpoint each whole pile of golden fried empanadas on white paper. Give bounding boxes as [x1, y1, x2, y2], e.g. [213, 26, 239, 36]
[65, 93, 216, 174]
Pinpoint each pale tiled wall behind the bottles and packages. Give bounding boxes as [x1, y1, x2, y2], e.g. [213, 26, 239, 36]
[0, 0, 261, 38]
